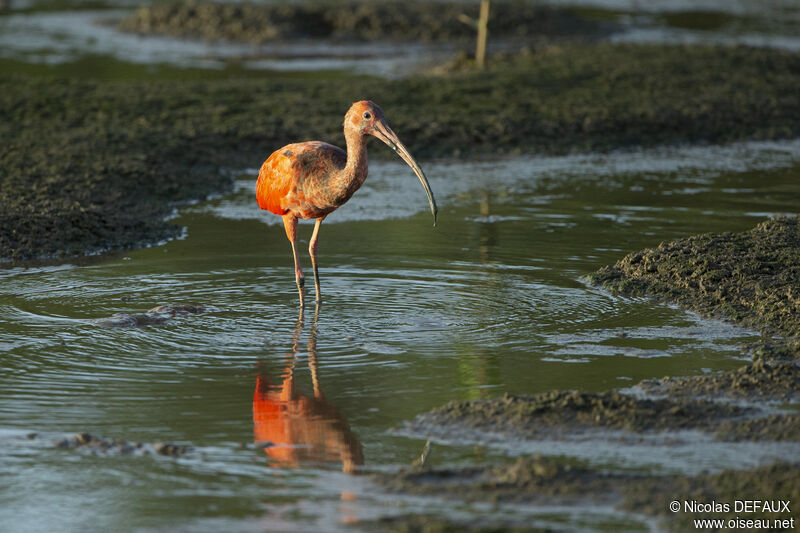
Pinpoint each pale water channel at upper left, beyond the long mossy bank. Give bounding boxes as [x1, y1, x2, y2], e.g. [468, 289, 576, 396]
[0, 9, 454, 78]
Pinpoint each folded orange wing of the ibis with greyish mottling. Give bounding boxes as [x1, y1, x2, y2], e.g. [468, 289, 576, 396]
[256, 141, 347, 215]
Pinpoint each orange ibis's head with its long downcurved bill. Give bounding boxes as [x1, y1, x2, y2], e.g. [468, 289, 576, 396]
[344, 100, 438, 226]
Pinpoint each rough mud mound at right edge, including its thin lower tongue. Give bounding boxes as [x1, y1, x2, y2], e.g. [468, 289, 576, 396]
[589, 216, 800, 394]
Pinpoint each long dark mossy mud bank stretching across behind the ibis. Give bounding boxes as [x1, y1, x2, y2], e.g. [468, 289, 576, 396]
[0, 45, 800, 260]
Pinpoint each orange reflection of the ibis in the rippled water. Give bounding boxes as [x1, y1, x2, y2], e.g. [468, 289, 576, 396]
[253, 306, 364, 473]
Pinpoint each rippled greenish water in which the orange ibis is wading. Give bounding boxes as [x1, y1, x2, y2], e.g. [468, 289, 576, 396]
[0, 141, 800, 531]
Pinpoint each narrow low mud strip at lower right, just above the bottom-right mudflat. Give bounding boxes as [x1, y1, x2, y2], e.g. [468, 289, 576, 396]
[406, 391, 800, 441]
